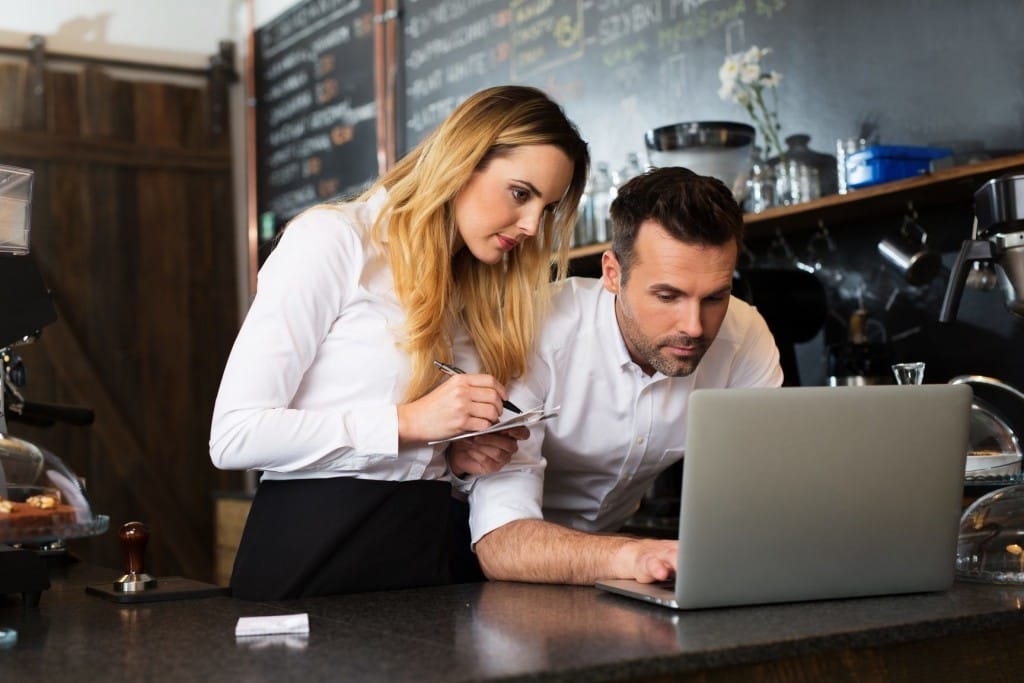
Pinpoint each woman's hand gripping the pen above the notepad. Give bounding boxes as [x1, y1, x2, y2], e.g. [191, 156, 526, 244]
[398, 375, 508, 444]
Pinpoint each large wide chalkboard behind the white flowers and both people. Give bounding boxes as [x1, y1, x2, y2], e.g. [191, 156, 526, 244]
[397, 0, 1024, 183]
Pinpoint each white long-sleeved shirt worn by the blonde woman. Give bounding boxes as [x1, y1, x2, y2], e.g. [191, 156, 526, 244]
[210, 190, 478, 480]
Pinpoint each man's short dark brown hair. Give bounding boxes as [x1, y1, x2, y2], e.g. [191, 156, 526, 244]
[610, 166, 743, 284]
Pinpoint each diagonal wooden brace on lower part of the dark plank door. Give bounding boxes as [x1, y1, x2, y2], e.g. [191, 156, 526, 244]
[37, 311, 209, 577]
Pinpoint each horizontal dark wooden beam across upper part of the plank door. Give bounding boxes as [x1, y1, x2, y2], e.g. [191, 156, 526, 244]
[0, 130, 231, 171]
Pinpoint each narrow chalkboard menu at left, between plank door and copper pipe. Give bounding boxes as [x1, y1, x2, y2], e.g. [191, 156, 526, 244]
[255, 0, 379, 243]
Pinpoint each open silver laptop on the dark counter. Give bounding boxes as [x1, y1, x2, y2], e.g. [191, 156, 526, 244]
[597, 384, 972, 609]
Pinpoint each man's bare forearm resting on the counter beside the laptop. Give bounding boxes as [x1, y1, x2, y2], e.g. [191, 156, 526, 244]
[476, 519, 639, 585]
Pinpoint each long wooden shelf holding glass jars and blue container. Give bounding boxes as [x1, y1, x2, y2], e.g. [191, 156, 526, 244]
[569, 154, 1024, 259]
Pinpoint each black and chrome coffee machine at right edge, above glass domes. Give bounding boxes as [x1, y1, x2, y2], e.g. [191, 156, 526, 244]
[939, 174, 1024, 323]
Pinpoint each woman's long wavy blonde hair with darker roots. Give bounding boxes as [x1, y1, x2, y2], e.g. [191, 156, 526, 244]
[360, 85, 590, 400]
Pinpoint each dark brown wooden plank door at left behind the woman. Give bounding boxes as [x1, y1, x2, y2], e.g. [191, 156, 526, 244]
[0, 57, 242, 580]
